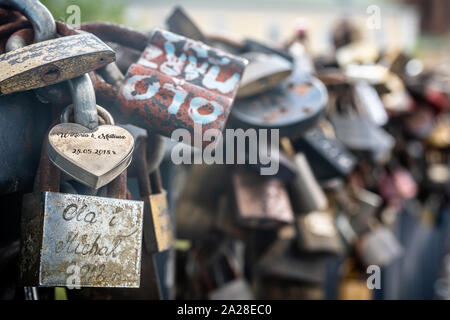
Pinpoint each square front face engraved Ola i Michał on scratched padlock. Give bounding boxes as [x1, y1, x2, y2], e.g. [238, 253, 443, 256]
[39, 192, 143, 288]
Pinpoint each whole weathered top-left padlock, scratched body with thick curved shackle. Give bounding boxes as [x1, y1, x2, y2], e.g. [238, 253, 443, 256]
[0, 0, 115, 94]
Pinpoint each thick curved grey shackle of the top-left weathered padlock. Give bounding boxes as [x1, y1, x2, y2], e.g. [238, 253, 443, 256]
[0, 0, 56, 42]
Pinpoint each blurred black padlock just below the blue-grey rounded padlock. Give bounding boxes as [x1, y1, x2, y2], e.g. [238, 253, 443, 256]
[294, 128, 356, 180]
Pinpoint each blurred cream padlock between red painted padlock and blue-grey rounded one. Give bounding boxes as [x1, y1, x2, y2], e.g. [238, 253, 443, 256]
[237, 52, 292, 99]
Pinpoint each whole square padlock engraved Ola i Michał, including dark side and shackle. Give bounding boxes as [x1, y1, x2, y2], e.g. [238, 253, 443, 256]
[20, 134, 143, 288]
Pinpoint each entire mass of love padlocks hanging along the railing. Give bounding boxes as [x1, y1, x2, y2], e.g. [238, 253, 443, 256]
[0, 0, 450, 300]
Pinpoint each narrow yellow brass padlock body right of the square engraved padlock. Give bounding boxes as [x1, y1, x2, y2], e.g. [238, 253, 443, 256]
[143, 191, 174, 253]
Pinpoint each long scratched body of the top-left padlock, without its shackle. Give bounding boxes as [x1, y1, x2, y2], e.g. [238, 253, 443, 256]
[0, 34, 115, 94]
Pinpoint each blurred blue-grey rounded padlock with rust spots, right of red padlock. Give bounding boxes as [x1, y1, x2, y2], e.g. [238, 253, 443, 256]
[232, 77, 328, 136]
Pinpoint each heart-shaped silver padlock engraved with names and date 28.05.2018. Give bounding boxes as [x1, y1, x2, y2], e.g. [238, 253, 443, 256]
[47, 105, 134, 189]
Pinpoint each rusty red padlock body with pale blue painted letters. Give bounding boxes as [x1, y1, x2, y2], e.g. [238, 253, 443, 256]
[119, 29, 246, 147]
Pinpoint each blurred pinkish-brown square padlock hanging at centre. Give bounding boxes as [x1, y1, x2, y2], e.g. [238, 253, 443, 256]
[233, 169, 294, 228]
